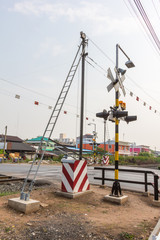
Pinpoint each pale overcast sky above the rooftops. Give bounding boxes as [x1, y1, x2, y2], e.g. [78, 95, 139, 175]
[0, 0, 160, 150]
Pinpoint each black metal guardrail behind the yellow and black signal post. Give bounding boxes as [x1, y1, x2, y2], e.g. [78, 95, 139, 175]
[94, 167, 159, 201]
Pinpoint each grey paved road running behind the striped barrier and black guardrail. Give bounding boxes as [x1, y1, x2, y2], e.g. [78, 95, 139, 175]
[0, 164, 160, 193]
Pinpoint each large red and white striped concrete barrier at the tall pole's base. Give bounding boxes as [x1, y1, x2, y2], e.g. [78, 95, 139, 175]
[61, 159, 90, 193]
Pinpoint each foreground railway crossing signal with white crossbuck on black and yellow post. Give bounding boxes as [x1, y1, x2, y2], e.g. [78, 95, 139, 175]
[107, 44, 137, 197]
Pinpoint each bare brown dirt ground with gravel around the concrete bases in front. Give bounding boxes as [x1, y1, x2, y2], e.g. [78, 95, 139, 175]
[0, 183, 160, 240]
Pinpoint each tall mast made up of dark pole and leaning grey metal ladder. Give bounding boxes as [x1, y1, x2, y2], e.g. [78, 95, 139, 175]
[20, 32, 87, 201]
